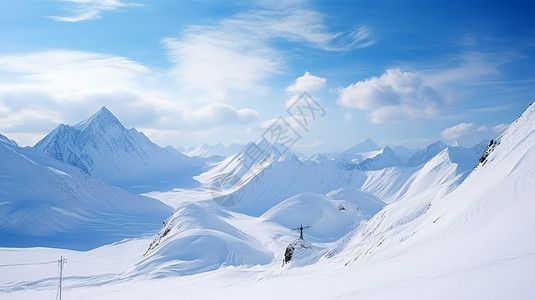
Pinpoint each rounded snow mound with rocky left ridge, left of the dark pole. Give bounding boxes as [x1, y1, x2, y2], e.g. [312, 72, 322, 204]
[136, 203, 273, 277]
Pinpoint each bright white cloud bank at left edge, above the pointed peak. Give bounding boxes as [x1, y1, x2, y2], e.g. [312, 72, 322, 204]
[0, 50, 149, 101]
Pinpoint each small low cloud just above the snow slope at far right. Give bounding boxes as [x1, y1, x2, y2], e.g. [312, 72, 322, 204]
[441, 123, 509, 144]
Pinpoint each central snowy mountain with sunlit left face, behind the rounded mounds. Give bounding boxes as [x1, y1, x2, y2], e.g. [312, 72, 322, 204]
[195, 141, 365, 216]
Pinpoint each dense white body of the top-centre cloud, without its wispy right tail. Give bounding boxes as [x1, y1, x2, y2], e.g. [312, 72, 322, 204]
[163, 31, 282, 96]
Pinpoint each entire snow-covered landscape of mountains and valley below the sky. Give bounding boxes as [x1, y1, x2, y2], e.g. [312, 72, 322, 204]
[0, 105, 535, 299]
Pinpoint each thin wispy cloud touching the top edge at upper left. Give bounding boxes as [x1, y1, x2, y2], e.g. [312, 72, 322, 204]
[50, 0, 138, 22]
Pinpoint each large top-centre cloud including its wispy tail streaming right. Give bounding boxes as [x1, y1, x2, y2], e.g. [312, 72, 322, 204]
[162, 8, 373, 97]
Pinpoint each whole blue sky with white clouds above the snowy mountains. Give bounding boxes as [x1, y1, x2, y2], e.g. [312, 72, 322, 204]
[0, 0, 535, 153]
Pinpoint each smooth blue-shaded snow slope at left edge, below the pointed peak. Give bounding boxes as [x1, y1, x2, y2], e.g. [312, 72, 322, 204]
[0, 135, 171, 250]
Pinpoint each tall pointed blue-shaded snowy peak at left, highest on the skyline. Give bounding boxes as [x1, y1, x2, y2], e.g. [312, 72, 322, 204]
[34, 107, 201, 188]
